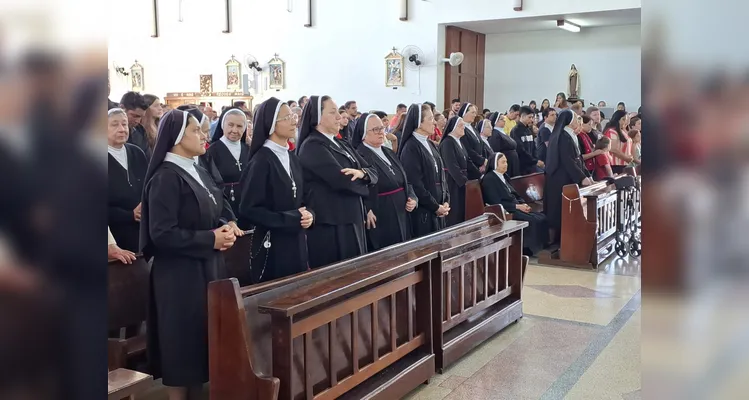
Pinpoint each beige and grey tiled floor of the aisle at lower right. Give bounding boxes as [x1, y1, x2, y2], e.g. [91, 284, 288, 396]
[142, 259, 641, 400]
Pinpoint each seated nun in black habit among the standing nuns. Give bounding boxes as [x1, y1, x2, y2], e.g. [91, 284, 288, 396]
[481, 153, 549, 256]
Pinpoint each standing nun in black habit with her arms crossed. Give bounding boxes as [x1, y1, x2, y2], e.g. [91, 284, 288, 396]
[297, 96, 377, 268]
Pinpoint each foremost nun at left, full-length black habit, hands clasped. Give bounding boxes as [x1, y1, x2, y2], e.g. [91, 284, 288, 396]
[140, 110, 236, 399]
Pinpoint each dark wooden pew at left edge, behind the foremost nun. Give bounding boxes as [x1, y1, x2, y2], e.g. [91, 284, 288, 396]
[107, 256, 151, 371]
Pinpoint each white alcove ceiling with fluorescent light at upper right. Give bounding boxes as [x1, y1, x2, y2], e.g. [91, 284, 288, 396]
[450, 8, 641, 34]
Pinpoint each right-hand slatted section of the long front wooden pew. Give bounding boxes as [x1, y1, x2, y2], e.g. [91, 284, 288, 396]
[432, 216, 528, 373]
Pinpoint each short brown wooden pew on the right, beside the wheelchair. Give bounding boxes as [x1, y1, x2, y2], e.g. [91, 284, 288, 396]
[538, 175, 640, 269]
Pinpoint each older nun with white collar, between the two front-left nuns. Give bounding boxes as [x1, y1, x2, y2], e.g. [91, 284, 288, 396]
[206, 108, 250, 214]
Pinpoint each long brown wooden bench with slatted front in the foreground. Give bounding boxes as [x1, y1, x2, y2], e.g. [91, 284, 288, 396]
[209, 214, 527, 400]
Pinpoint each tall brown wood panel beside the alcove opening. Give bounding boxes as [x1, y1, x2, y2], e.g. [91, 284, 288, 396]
[444, 26, 486, 109]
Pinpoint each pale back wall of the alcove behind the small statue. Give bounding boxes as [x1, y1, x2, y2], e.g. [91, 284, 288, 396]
[484, 25, 641, 110]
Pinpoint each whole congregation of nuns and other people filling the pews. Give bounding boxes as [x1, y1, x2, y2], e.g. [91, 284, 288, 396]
[108, 86, 642, 399]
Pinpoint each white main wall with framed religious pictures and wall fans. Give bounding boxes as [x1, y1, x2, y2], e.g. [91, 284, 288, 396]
[109, 0, 641, 112]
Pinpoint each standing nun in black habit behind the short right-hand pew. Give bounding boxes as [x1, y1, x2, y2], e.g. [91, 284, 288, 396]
[544, 110, 593, 236]
